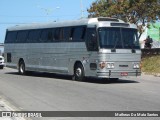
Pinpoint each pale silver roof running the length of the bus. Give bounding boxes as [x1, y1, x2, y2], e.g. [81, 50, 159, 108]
[7, 17, 135, 31]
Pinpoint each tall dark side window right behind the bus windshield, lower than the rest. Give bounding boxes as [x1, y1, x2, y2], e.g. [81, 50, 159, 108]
[87, 28, 98, 51]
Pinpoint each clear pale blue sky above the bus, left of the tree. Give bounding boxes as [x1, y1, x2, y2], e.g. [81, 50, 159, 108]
[0, 0, 95, 43]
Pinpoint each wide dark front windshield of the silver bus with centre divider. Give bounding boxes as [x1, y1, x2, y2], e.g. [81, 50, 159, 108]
[98, 27, 140, 49]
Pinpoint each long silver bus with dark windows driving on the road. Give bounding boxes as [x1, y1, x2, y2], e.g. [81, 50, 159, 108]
[4, 17, 141, 80]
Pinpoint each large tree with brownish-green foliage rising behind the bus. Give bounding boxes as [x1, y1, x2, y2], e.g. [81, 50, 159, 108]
[87, 0, 160, 37]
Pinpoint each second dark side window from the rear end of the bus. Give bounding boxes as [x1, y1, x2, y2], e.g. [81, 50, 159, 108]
[16, 31, 28, 43]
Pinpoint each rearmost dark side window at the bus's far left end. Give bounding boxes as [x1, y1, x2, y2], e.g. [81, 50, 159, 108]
[5, 31, 17, 43]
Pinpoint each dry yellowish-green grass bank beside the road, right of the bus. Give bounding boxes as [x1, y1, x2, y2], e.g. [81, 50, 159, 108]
[142, 55, 160, 73]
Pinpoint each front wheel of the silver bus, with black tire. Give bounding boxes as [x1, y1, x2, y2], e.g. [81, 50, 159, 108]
[74, 63, 85, 81]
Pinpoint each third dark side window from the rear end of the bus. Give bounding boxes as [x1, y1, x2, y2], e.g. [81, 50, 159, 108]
[27, 30, 41, 43]
